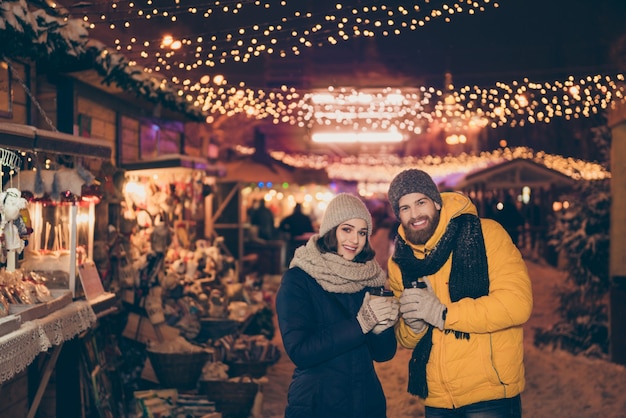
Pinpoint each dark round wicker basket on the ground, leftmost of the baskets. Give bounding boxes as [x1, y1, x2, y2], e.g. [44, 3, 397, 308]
[146, 337, 213, 390]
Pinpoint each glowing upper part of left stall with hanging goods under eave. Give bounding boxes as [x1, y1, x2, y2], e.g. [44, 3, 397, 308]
[0, 124, 111, 294]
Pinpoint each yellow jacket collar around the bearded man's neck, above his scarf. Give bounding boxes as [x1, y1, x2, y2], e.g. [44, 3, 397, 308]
[398, 192, 478, 258]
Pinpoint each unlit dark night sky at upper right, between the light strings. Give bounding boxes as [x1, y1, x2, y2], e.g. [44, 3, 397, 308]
[354, 0, 626, 84]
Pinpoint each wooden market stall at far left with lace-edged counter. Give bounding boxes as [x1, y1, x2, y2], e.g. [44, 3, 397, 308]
[0, 123, 120, 418]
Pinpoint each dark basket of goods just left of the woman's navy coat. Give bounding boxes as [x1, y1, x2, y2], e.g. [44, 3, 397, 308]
[226, 335, 280, 378]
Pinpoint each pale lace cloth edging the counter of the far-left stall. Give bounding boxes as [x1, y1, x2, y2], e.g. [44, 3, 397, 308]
[0, 301, 96, 383]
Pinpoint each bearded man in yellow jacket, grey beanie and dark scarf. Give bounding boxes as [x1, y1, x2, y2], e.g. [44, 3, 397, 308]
[388, 169, 532, 418]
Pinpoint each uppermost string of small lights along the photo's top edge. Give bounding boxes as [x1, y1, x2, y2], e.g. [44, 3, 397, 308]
[79, 0, 499, 68]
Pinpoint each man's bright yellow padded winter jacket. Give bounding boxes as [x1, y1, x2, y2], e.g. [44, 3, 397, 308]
[388, 193, 533, 408]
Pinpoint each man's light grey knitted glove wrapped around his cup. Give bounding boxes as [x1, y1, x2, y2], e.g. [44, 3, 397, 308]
[400, 281, 446, 331]
